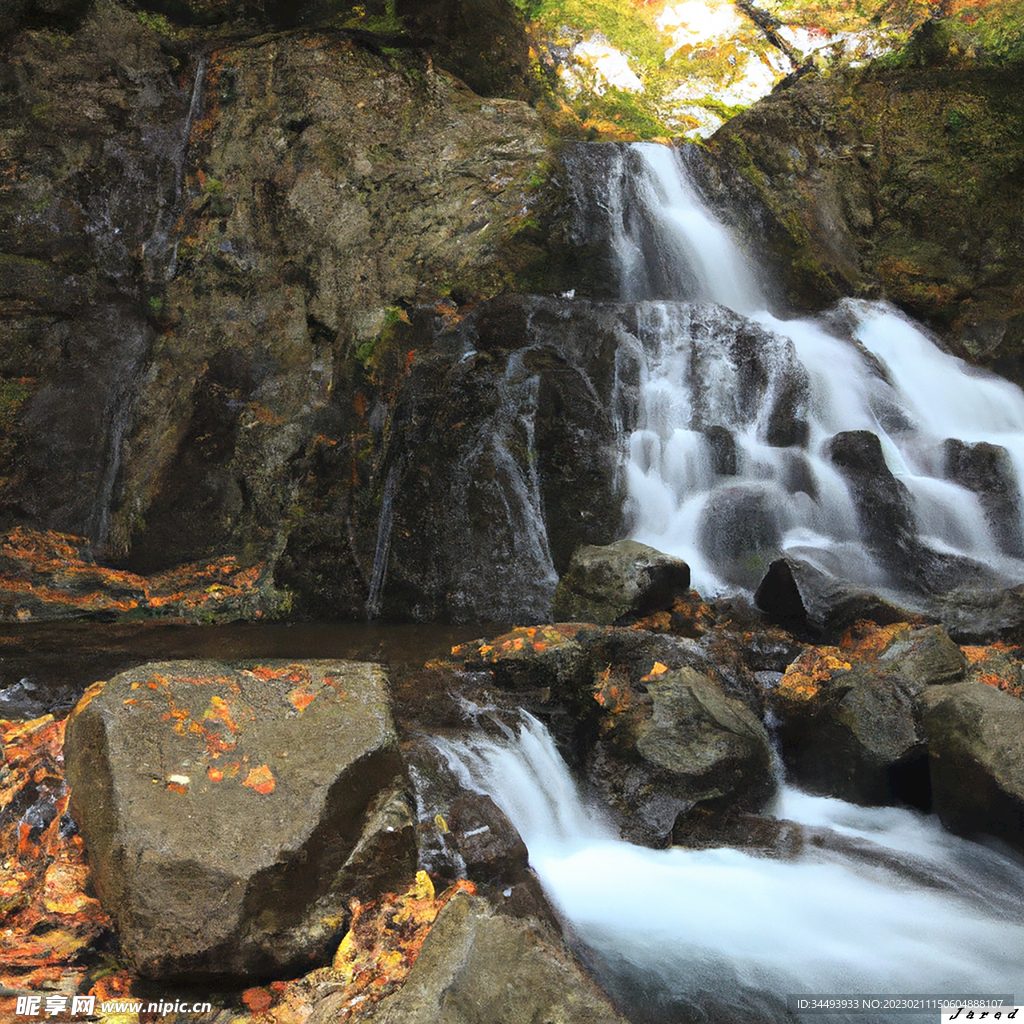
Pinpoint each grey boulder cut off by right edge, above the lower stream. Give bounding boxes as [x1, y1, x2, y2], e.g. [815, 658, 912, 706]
[922, 682, 1024, 847]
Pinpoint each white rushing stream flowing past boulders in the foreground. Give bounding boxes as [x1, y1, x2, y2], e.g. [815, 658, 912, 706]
[441, 718, 1024, 1024]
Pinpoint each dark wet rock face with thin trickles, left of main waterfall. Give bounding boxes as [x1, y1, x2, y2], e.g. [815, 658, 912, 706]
[279, 296, 628, 622]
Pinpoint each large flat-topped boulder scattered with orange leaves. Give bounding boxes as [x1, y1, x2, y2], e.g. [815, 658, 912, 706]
[65, 660, 416, 981]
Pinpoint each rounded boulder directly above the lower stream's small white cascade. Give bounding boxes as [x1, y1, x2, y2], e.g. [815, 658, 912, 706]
[587, 663, 775, 847]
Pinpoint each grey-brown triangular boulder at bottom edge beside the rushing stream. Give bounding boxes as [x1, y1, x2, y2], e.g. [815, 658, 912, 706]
[348, 893, 625, 1024]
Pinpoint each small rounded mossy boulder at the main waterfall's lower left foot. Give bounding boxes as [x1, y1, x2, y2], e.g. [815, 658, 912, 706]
[553, 541, 690, 626]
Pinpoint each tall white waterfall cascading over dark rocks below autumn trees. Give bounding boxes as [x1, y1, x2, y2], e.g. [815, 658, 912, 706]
[609, 144, 1024, 594]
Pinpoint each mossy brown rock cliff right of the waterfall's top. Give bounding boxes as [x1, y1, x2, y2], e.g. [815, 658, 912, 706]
[711, 60, 1024, 381]
